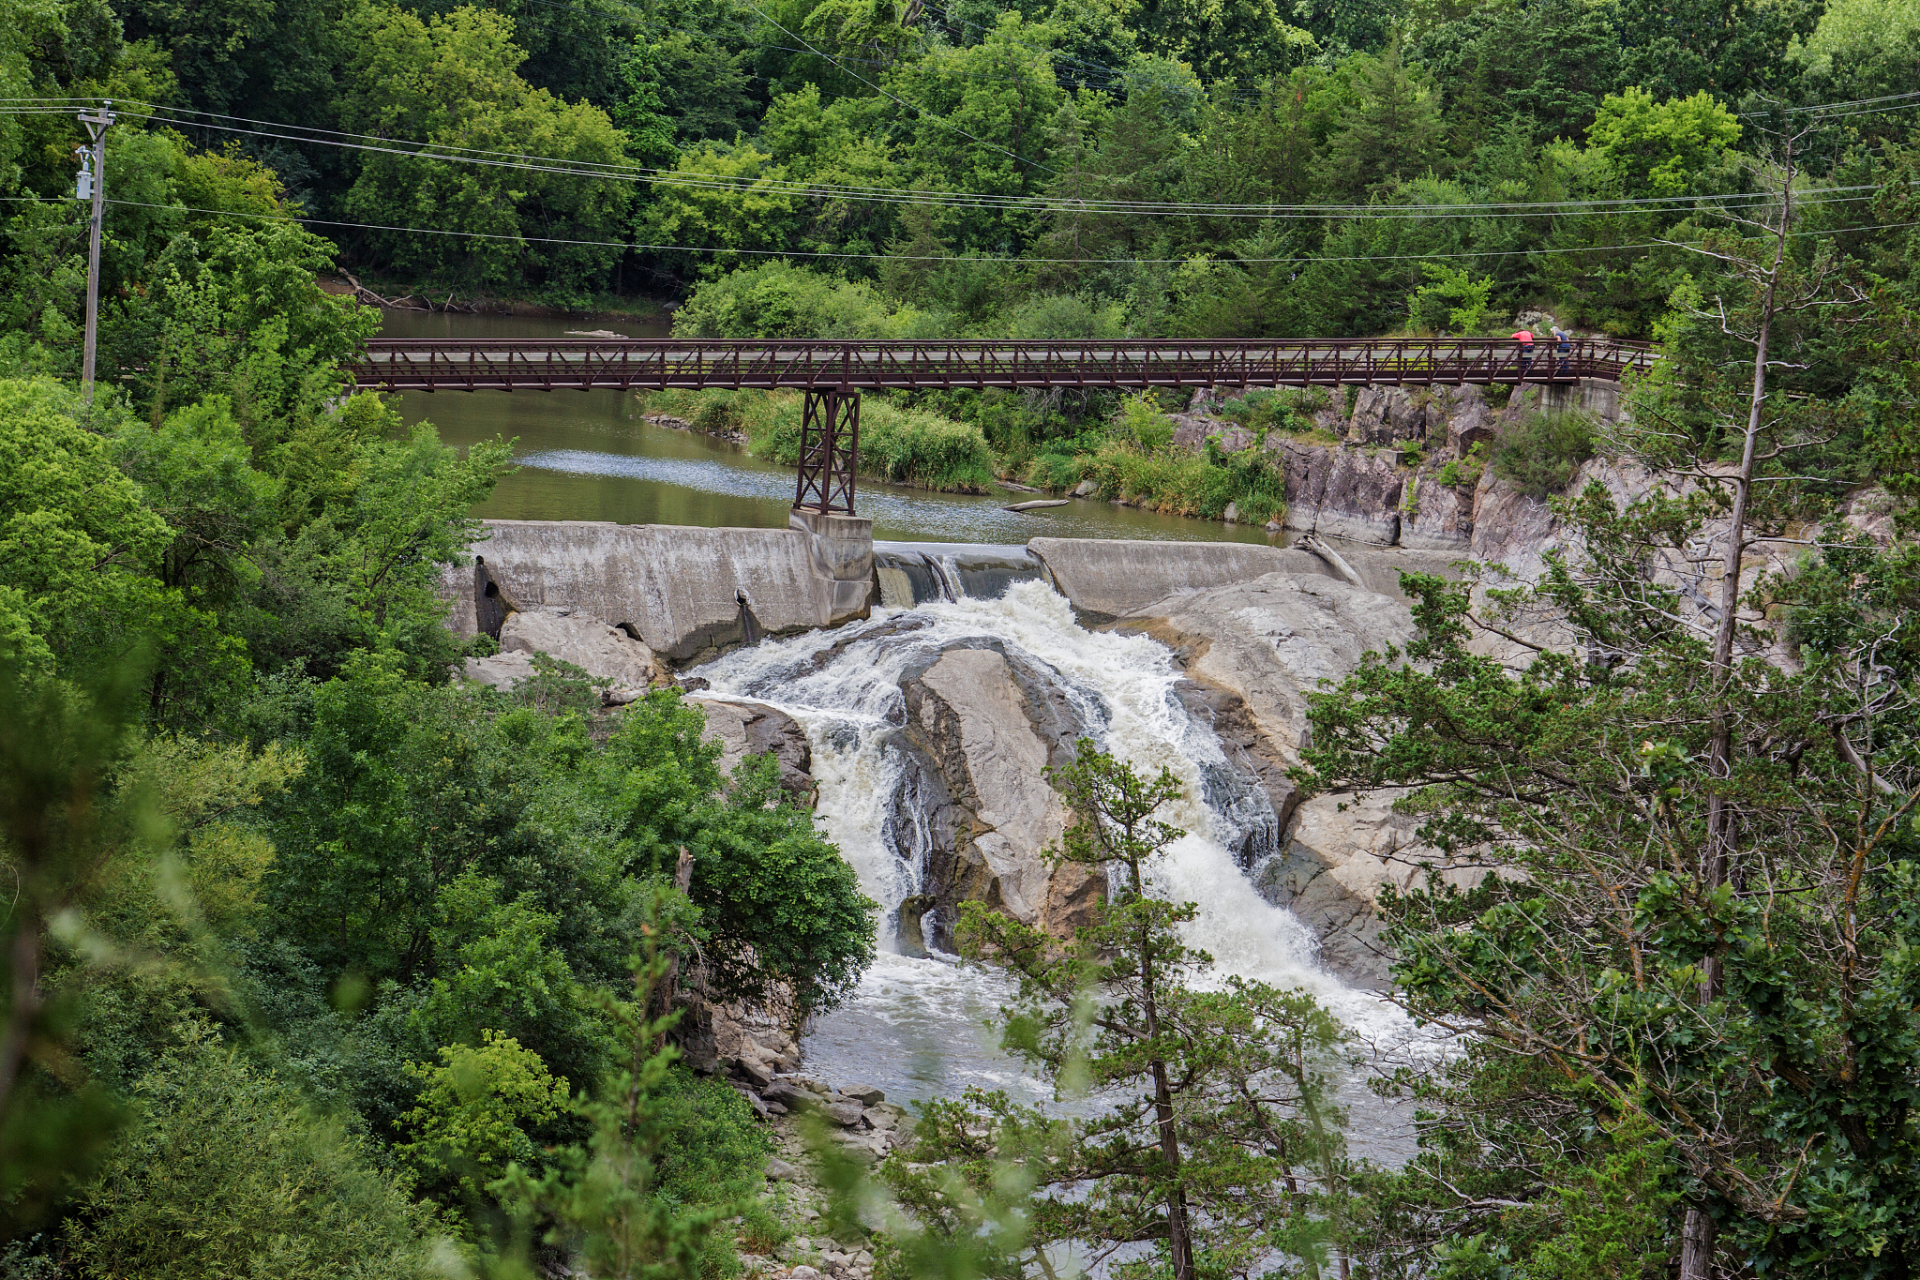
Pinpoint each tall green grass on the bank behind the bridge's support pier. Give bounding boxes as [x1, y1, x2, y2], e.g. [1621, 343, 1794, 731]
[641, 391, 993, 493]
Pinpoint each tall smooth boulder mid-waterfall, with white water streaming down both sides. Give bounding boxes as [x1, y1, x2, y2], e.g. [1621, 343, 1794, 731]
[902, 649, 1102, 942]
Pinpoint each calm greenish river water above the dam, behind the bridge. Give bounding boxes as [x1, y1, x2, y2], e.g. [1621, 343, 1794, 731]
[380, 311, 1269, 543]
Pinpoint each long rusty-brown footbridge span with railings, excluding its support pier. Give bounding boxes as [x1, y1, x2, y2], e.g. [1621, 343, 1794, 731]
[349, 338, 1657, 391]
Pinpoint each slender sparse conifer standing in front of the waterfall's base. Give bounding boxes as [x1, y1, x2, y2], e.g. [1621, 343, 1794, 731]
[917, 739, 1346, 1280]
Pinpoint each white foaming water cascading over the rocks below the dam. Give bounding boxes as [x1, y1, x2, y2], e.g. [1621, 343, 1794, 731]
[699, 581, 1411, 1098]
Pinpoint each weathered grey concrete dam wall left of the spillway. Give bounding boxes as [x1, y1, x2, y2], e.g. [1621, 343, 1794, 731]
[447, 516, 874, 666]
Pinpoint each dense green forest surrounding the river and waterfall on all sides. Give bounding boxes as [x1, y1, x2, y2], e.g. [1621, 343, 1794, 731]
[0, 0, 1920, 1280]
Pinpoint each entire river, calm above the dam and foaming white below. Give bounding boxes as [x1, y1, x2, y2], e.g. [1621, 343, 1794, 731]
[382, 313, 1425, 1163]
